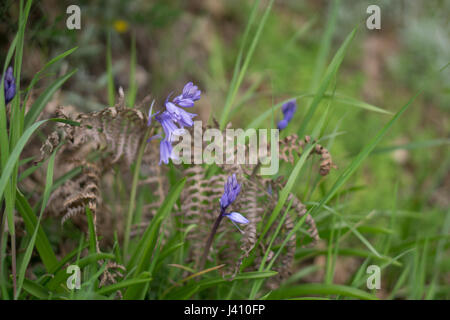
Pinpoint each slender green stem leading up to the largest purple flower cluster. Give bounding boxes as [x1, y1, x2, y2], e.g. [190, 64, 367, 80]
[123, 129, 150, 261]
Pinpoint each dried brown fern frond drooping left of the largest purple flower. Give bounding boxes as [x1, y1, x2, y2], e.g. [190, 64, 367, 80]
[36, 96, 155, 246]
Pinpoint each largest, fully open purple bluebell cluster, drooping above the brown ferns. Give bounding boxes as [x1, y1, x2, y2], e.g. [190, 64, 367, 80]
[147, 82, 201, 164]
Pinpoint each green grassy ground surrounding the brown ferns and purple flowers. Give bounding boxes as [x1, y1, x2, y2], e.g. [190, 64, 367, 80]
[0, 1, 450, 299]
